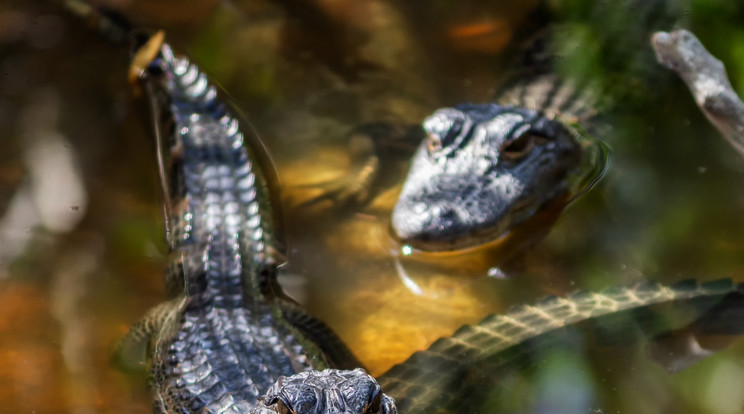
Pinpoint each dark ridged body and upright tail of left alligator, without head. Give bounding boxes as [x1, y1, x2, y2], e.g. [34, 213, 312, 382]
[118, 36, 374, 413]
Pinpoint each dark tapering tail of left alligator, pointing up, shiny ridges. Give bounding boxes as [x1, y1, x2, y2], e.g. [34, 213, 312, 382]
[145, 45, 276, 308]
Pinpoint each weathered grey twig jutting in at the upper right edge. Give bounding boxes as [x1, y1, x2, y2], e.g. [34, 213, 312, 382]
[651, 30, 744, 158]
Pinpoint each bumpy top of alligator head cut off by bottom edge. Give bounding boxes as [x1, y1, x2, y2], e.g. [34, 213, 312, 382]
[251, 369, 398, 414]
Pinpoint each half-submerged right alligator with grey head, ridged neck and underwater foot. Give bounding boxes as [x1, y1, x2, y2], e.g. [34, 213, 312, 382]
[303, 53, 609, 252]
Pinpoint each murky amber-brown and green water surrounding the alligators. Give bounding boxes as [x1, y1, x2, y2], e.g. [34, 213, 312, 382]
[0, 0, 744, 414]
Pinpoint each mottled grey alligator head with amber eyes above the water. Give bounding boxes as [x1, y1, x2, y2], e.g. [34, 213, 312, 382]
[392, 103, 581, 250]
